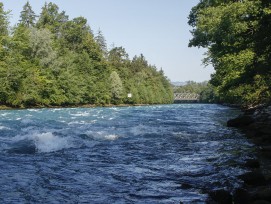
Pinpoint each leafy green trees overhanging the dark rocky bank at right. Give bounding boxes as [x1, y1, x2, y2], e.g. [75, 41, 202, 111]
[188, 0, 271, 108]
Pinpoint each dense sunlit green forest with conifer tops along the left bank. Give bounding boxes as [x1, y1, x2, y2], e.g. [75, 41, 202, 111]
[0, 2, 173, 108]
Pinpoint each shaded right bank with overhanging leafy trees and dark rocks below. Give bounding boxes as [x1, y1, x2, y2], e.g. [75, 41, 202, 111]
[189, 0, 271, 203]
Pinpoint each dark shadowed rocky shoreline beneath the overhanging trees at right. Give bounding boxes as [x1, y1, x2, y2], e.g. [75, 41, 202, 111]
[207, 106, 271, 204]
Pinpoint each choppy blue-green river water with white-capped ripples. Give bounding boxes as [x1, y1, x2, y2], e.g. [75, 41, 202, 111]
[0, 104, 254, 203]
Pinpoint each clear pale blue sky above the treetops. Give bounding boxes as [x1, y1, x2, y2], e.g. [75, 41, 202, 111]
[2, 0, 213, 82]
